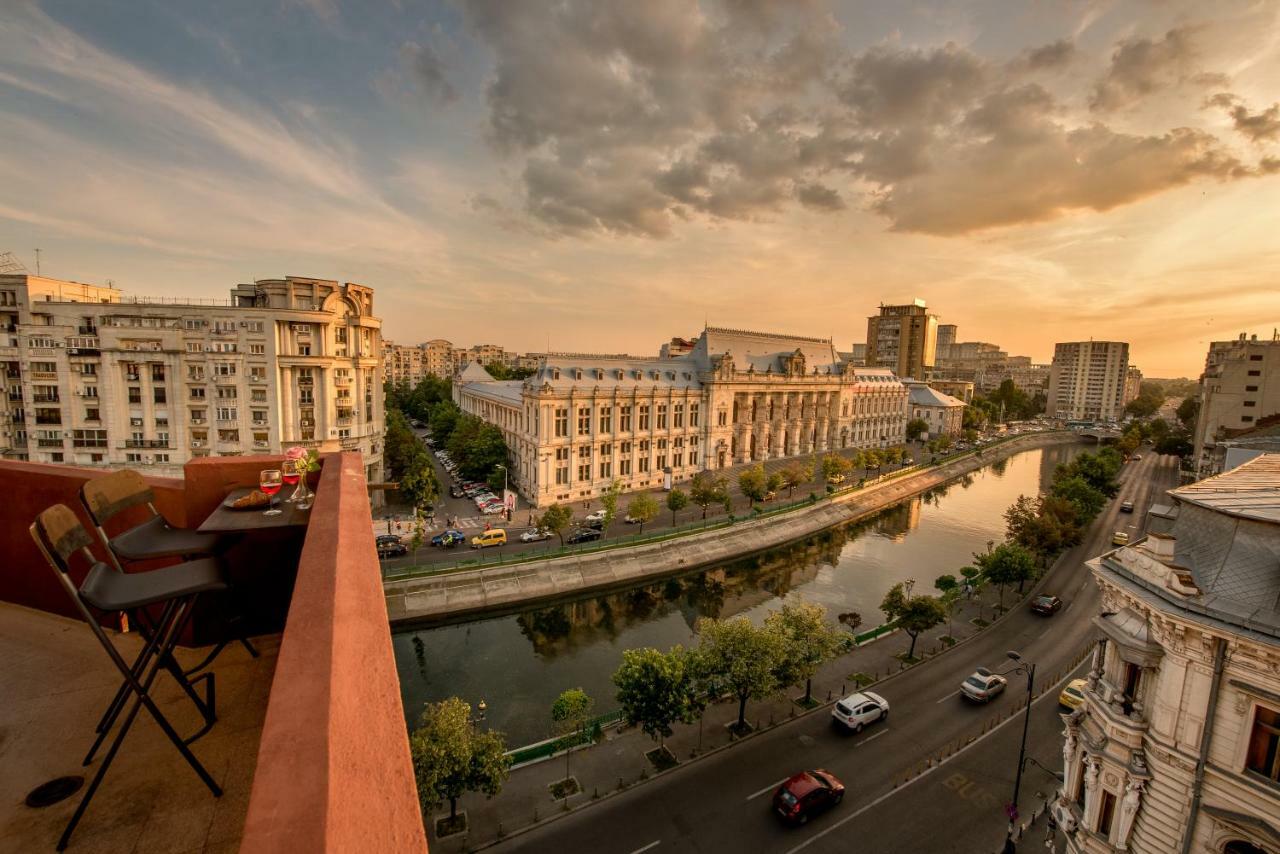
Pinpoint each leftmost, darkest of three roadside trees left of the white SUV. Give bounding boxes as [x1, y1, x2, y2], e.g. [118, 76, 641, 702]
[613, 647, 698, 745]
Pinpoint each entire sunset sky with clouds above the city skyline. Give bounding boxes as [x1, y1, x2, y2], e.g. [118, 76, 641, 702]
[0, 0, 1280, 376]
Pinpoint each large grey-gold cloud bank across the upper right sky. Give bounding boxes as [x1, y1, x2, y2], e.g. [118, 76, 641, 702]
[453, 0, 1268, 238]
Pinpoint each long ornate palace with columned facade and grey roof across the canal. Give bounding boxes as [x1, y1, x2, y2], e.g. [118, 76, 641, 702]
[453, 328, 906, 506]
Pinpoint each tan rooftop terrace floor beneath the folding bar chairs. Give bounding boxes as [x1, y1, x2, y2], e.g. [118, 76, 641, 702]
[0, 603, 280, 854]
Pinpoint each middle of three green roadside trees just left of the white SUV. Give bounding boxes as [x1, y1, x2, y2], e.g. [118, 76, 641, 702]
[698, 617, 781, 731]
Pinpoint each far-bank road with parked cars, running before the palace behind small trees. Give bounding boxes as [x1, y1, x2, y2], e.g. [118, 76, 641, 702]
[374, 429, 1059, 570]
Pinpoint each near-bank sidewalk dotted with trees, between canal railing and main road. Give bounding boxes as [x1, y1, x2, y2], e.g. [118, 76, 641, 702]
[426, 590, 1018, 851]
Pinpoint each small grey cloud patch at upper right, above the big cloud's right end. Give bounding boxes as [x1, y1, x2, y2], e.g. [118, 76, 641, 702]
[1089, 27, 1197, 113]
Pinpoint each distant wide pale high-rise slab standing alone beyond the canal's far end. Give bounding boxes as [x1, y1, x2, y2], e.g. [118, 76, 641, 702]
[1046, 341, 1129, 421]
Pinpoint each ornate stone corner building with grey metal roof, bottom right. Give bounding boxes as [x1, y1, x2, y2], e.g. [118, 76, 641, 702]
[1052, 455, 1280, 854]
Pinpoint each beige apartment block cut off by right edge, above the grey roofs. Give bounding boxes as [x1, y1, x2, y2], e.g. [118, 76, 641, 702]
[1194, 333, 1280, 475]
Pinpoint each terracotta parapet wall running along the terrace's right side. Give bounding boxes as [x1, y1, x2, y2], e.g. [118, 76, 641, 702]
[241, 453, 426, 854]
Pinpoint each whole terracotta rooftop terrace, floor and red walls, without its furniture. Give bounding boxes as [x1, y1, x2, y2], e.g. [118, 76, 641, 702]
[0, 453, 426, 854]
